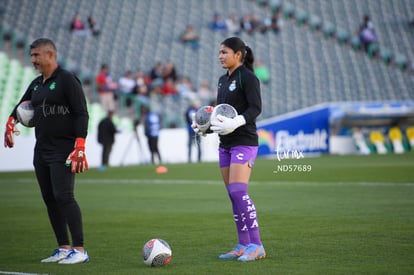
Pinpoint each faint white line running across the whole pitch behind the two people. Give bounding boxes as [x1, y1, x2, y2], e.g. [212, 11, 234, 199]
[0, 178, 414, 188]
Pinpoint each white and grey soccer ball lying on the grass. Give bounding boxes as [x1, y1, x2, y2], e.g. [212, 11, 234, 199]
[142, 238, 172, 266]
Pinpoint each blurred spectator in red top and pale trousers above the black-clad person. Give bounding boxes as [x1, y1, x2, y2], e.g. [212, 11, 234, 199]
[95, 64, 118, 112]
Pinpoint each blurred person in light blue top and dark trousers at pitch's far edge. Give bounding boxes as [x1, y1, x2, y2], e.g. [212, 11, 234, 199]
[142, 106, 162, 164]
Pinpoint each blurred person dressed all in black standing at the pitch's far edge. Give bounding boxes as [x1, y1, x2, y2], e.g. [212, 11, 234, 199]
[98, 111, 117, 171]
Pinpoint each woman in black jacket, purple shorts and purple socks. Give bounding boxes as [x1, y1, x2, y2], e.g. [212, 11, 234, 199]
[202, 37, 266, 262]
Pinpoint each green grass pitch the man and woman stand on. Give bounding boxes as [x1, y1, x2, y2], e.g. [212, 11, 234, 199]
[0, 153, 414, 275]
